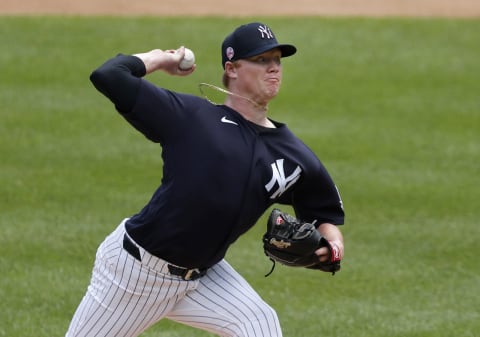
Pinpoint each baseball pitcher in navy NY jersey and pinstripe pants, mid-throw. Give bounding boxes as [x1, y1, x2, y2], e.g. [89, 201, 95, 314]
[66, 22, 344, 337]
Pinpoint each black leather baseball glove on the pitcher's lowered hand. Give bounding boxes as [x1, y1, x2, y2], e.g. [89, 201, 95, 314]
[263, 209, 341, 276]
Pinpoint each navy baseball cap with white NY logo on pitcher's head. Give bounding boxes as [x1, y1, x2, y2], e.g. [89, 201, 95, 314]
[222, 22, 297, 68]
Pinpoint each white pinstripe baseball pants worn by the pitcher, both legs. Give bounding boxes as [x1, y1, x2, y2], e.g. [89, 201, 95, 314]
[66, 222, 282, 337]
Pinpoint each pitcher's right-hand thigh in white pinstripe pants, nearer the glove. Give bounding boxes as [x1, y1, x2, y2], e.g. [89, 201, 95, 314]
[167, 260, 282, 337]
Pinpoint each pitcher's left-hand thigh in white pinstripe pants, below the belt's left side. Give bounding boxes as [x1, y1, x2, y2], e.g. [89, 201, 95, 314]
[66, 220, 193, 337]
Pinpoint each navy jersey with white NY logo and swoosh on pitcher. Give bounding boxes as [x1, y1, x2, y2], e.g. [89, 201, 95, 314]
[91, 53, 344, 268]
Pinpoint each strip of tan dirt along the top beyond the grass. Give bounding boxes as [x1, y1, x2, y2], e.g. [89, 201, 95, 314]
[0, 0, 480, 17]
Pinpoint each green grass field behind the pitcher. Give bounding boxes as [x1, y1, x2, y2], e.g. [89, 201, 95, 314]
[0, 17, 480, 337]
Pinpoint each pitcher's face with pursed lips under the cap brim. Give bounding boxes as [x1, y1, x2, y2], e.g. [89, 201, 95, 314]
[237, 49, 282, 103]
